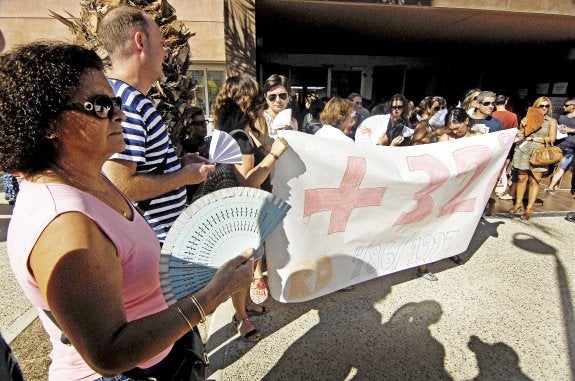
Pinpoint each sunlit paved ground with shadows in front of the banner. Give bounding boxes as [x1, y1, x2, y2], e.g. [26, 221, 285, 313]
[0, 191, 575, 381]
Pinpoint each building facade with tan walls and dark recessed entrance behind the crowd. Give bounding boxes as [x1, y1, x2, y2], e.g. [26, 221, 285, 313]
[0, 0, 575, 114]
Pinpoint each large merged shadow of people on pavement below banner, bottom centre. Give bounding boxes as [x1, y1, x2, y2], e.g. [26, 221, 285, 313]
[263, 296, 451, 380]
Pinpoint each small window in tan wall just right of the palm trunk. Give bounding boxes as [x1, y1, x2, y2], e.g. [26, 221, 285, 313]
[190, 67, 225, 119]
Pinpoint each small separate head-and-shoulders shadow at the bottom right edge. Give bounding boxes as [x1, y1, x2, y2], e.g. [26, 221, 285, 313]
[467, 335, 531, 381]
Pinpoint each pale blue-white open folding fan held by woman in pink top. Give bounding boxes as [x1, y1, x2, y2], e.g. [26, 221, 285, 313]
[160, 187, 290, 305]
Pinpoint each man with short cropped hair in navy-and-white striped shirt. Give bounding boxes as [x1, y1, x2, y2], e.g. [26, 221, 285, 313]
[98, 6, 215, 243]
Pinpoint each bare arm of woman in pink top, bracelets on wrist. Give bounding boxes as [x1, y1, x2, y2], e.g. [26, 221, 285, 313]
[29, 212, 253, 376]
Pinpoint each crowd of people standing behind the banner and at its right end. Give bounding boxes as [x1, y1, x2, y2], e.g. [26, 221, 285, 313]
[292, 88, 575, 281]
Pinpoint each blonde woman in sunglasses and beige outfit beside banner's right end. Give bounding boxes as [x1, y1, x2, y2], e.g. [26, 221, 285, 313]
[509, 97, 557, 220]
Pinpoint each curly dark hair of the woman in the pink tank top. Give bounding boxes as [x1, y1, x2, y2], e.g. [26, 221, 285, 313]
[0, 41, 104, 173]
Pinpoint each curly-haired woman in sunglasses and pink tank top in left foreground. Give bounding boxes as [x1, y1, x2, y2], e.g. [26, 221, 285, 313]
[0, 40, 254, 381]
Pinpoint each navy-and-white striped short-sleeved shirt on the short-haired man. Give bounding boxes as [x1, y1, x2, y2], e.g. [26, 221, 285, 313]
[109, 78, 186, 243]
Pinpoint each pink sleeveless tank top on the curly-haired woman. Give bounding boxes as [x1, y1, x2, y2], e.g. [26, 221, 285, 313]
[7, 181, 171, 381]
